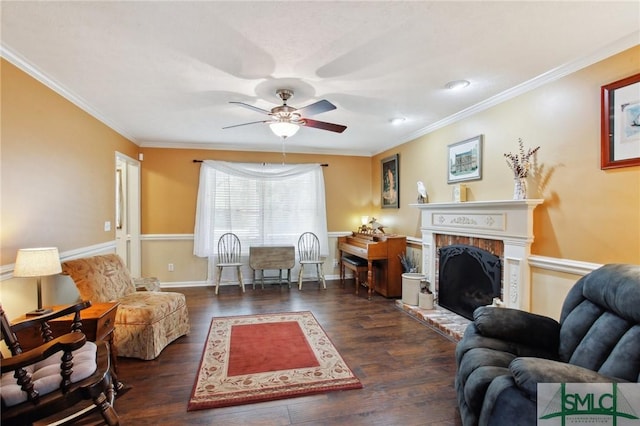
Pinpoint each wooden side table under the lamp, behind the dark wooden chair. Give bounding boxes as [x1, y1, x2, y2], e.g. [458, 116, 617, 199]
[13, 302, 119, 372]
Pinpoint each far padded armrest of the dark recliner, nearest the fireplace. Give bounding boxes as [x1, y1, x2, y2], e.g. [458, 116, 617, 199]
[473, 306, 560, 354]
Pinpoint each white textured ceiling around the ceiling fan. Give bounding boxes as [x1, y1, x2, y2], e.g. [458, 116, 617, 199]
[0, 1, 640, 155]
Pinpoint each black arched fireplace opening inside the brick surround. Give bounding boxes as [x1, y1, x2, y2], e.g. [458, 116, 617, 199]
[438, 244, 502, 320]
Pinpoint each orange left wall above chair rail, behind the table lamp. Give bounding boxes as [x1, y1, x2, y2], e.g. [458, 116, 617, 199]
[0, 59, 138, 265]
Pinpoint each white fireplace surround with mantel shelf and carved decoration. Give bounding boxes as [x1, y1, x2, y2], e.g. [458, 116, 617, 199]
[410, 199, 544, 311]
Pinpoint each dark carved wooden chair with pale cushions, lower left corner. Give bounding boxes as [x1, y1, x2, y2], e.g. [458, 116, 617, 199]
[0, 302, 124, 425]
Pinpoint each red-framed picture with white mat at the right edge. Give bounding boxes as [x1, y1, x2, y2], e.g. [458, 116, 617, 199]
[600, 74, 640, 170]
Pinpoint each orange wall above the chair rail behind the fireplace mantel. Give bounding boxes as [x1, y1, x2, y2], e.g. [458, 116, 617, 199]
[372, 46, 640, 264]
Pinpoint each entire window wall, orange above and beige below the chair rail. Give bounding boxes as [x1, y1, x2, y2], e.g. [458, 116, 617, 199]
[141, 148, 371, 286]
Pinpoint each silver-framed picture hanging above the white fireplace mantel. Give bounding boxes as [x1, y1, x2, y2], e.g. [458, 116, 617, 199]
[447, 135, 483, 183]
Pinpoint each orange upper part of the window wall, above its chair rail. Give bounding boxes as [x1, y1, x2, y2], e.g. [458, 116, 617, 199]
[141, 148, 371, 234]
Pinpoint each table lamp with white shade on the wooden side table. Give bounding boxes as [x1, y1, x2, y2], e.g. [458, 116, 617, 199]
[13, 247, 62, 316]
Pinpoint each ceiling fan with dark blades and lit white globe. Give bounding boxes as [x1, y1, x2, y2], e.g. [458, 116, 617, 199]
[223, 89, 347, 139]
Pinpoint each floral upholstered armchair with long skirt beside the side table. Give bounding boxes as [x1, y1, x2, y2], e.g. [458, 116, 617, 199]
[62, 254, 190, 360]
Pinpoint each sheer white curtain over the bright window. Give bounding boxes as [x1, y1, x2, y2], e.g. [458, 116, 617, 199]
[194, 160, 329, 257]
